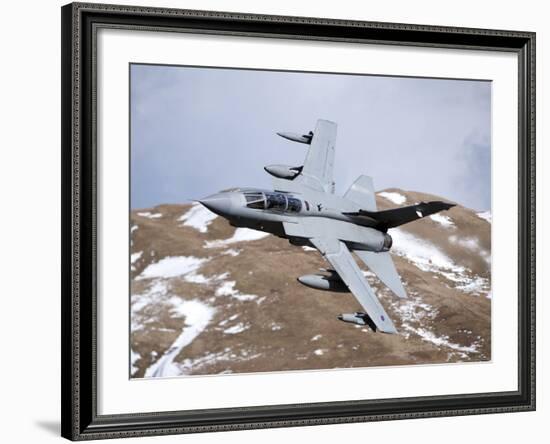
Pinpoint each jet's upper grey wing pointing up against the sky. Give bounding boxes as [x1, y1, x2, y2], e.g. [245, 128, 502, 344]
[273, 119, 337, 193]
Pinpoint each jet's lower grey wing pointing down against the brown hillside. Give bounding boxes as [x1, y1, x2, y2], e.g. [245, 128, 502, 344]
[310, 238, 397, 333]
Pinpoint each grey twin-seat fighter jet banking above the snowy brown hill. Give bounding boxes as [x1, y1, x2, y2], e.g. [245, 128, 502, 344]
[199, 120, 454, 333]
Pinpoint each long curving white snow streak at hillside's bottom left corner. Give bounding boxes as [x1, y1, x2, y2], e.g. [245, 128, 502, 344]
[145, 296, 215, 377]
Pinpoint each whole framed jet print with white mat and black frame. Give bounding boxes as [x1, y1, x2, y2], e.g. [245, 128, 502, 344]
[62, 3, 535, 440]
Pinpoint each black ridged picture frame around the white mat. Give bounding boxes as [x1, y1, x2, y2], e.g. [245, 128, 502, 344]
[61, 3, 535, 440]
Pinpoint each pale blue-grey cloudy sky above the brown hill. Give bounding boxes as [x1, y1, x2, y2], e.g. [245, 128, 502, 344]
[130, 65, 491, 210]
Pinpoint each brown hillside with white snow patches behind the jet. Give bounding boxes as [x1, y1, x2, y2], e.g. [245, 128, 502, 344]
[130, 189, 491, 378]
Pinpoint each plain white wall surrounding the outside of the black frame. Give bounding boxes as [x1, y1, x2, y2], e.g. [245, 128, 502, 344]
[0, 0, 550, 444]
